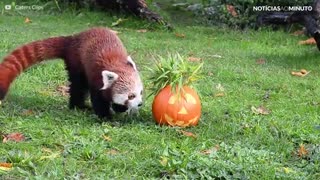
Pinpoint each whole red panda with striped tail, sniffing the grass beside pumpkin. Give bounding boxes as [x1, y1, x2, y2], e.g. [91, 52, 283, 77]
[0, 28, 143, 118]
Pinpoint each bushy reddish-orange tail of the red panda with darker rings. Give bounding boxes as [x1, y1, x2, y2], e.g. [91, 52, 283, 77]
[0, 37, 68, 100]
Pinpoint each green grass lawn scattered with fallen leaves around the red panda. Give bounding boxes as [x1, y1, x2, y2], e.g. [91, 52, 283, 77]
[0, 3, 320, 179]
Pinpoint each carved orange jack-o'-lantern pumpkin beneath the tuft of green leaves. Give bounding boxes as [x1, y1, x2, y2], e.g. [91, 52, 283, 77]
[152, 86, 201, 127]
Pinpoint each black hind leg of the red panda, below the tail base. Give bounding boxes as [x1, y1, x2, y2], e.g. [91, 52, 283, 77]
[69, 71, 89, 109]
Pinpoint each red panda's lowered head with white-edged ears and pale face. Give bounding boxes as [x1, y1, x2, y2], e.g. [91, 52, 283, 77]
[101, 56, 143, 113]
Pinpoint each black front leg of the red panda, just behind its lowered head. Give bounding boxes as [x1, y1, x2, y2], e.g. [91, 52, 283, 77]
[90, 89, 112, 119]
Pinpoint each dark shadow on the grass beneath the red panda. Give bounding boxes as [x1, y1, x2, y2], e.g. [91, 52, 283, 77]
[2, 95, 151, 126]
